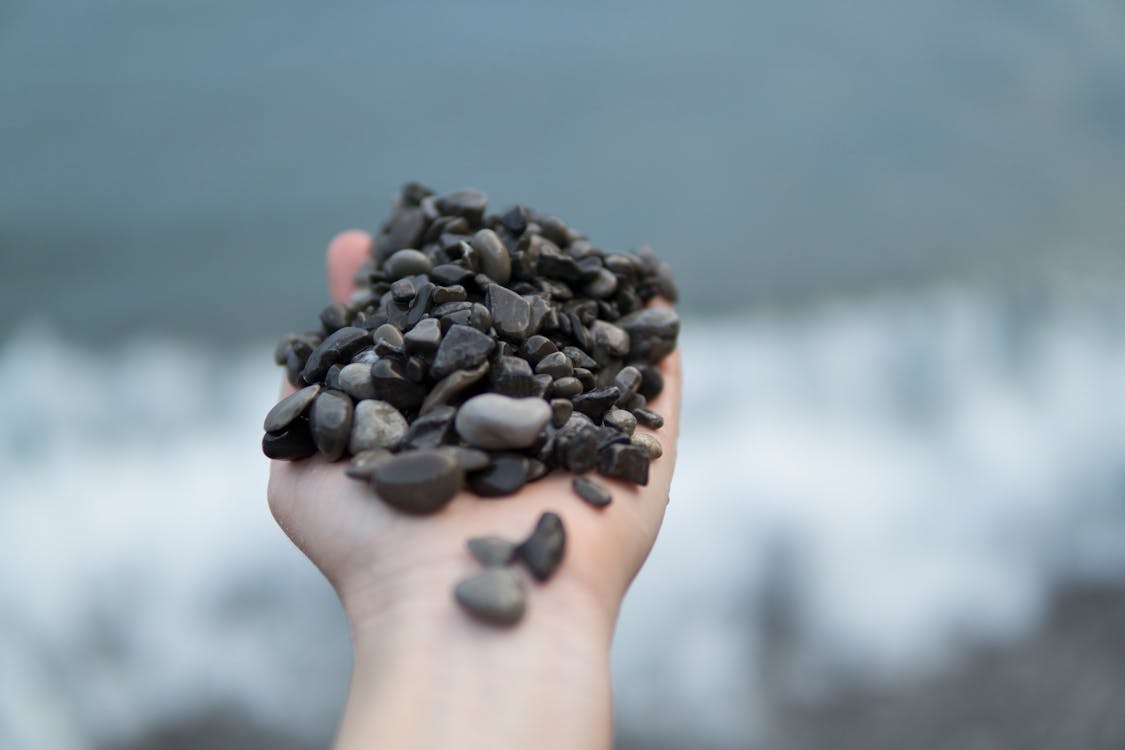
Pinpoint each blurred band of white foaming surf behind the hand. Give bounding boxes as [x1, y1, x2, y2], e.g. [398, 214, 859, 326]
[0, 280, 1125, 750]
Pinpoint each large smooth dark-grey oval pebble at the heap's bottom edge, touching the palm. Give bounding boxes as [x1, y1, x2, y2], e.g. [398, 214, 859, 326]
[371, 451, 465, 514]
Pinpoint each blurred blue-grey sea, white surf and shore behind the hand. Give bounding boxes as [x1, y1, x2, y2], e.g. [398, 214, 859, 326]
[0, 0, 1125, 750]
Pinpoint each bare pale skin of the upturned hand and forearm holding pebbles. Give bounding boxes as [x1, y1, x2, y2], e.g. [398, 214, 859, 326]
[269, 232, 681, 750]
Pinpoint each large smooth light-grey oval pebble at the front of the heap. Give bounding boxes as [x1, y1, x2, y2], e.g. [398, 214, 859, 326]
[456, 394, 551, 450]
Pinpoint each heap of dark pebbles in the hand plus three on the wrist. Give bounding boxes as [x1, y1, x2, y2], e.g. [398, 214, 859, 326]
[262, 182, 680, 622]
